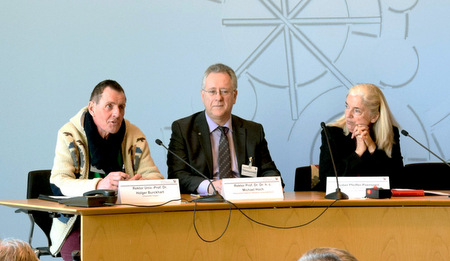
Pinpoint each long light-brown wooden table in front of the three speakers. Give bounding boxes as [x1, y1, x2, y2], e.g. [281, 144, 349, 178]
[0, 192, 450, 261]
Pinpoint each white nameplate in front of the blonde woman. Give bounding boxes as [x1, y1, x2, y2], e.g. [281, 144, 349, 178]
[326, 176, 390, 198]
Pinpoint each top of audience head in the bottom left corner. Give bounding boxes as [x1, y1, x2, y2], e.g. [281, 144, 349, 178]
[0, 239, 39, 261]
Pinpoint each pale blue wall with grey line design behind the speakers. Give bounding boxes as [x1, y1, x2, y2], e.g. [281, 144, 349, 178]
[0, 0, 450, 258]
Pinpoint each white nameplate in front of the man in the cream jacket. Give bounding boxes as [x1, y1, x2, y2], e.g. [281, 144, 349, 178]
[118, 179, 181, 205]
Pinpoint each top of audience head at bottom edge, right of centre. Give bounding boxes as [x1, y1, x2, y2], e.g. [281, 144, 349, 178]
[298, 247, 358, 261]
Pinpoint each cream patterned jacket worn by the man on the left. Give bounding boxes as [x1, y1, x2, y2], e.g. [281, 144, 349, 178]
[50, 107, 164, 254]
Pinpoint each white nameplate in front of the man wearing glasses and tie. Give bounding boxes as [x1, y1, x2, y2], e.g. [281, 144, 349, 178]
[222, 177, 284, 200]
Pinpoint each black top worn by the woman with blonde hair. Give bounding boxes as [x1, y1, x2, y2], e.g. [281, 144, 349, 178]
[314, 127, 403, 191]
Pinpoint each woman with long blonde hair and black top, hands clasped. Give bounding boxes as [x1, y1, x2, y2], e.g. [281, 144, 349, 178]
[316, 84, 403, 191]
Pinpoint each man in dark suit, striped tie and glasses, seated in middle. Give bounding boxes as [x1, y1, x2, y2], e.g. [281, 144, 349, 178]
[167, 64, 281, 194]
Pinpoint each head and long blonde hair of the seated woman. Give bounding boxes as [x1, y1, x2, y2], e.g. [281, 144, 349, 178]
[330, 83, 398, 157]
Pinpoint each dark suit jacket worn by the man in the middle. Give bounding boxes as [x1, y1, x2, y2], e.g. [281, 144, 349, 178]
[167, 111, 281, 194]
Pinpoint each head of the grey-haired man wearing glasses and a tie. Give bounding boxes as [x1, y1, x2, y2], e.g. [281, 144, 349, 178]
[201, 64, 237, 125]
